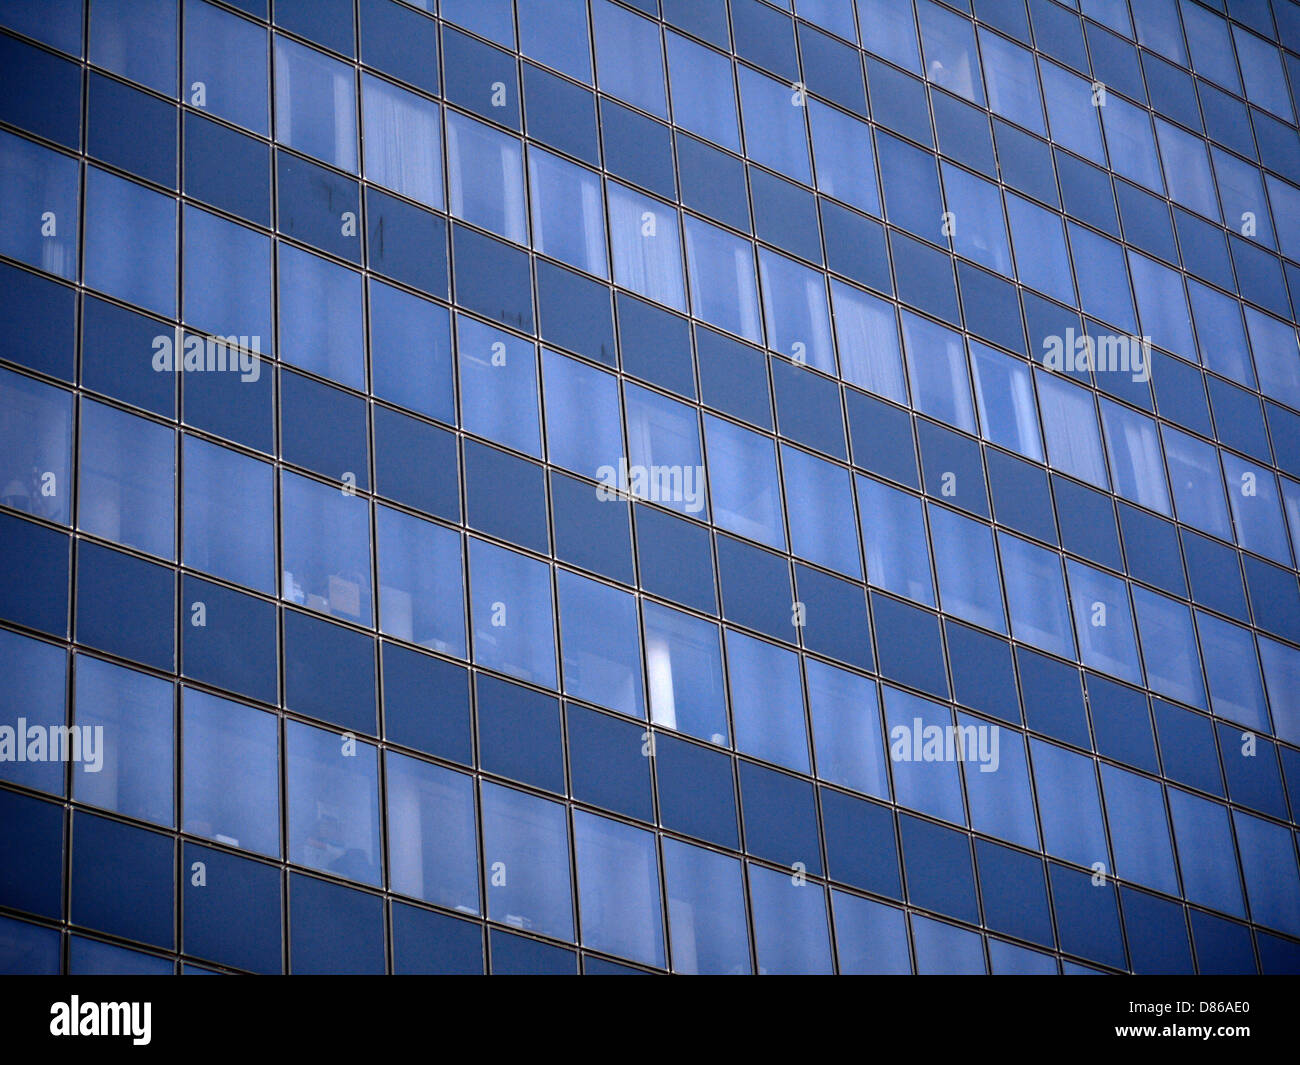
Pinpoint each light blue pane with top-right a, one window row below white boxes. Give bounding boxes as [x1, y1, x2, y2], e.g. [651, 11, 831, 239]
[285, 722, 380, 884]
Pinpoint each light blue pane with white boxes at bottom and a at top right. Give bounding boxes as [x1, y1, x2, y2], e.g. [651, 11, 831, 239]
[281, 471, 373, 624]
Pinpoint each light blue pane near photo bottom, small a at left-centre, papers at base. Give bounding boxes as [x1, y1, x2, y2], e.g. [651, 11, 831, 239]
[481, 782, 573, 940]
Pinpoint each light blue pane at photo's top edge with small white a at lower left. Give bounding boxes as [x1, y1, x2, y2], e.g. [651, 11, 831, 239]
[181, 0, 269, 137]
